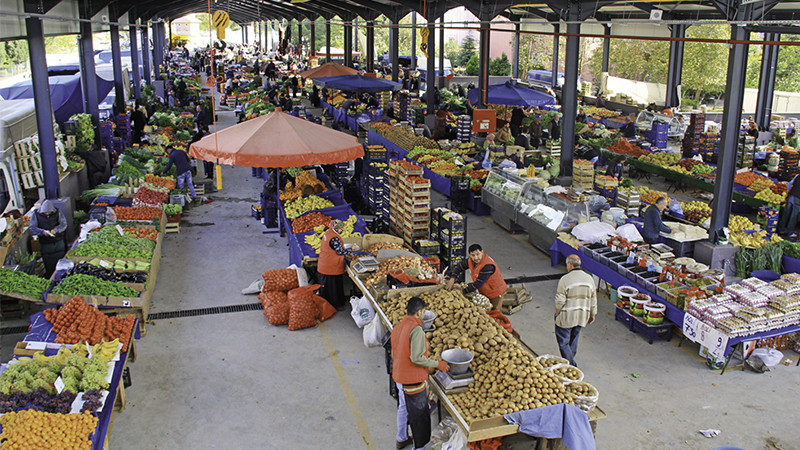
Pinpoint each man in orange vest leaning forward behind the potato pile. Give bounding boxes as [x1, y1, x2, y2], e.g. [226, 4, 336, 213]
[445, 244, 508, 309]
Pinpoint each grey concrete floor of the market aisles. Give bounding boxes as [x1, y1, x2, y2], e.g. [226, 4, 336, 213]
[0, 96, 800, 450]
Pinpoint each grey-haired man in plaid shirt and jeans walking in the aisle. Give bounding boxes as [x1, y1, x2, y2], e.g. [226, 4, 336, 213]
[555, 255, 597, 367]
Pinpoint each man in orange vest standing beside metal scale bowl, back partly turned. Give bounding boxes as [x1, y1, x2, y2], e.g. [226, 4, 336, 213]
[392, 297, 450, 450]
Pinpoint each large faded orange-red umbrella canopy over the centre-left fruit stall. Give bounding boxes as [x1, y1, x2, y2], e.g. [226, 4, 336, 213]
[189, 111, 364, 167]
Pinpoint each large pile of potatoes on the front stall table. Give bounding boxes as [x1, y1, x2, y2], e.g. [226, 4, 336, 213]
[381, 289, 573, 422]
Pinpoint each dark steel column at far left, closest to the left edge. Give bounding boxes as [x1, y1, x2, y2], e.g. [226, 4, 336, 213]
[25, 17, 59, 199]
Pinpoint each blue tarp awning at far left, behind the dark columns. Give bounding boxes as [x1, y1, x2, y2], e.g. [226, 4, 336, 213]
[0, 74, 114, 123]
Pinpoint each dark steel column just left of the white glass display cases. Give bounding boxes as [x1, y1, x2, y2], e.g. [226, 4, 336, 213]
[561, 16, 581, 184]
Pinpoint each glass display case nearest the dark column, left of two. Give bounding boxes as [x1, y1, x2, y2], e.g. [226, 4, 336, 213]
[481, 168, 531, 231]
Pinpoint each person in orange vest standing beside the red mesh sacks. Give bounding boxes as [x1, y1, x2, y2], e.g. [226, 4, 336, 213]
[317, 220, 350, 311]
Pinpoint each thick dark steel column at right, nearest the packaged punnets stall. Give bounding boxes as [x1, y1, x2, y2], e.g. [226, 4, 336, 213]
[709, 23, 750, 242]
